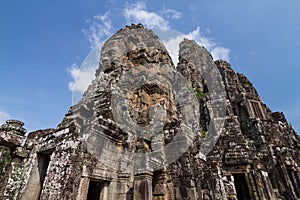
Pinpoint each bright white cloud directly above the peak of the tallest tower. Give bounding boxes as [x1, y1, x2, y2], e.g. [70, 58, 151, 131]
[123, 1, 170, 29]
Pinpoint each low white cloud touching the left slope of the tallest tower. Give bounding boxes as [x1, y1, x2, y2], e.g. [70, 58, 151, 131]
[68, 63, 96, 93]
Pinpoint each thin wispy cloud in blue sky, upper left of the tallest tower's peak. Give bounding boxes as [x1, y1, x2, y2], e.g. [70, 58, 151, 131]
[82, 12, 113, 48]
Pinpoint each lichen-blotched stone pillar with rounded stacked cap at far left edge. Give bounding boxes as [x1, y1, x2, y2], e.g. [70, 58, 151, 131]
[0, 120, 29, 199]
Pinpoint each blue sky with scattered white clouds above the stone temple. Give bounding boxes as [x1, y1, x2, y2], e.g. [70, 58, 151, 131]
[0, 0, 300, 133]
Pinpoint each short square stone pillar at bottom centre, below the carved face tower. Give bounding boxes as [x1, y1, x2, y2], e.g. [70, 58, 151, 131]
[134, 172, 153, 200]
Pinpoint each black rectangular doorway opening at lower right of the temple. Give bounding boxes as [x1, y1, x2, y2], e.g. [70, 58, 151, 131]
[233, 173, 251, 200]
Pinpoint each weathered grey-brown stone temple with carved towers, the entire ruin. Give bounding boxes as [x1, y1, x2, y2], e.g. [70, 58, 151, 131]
[0, 24, 300, 200]
